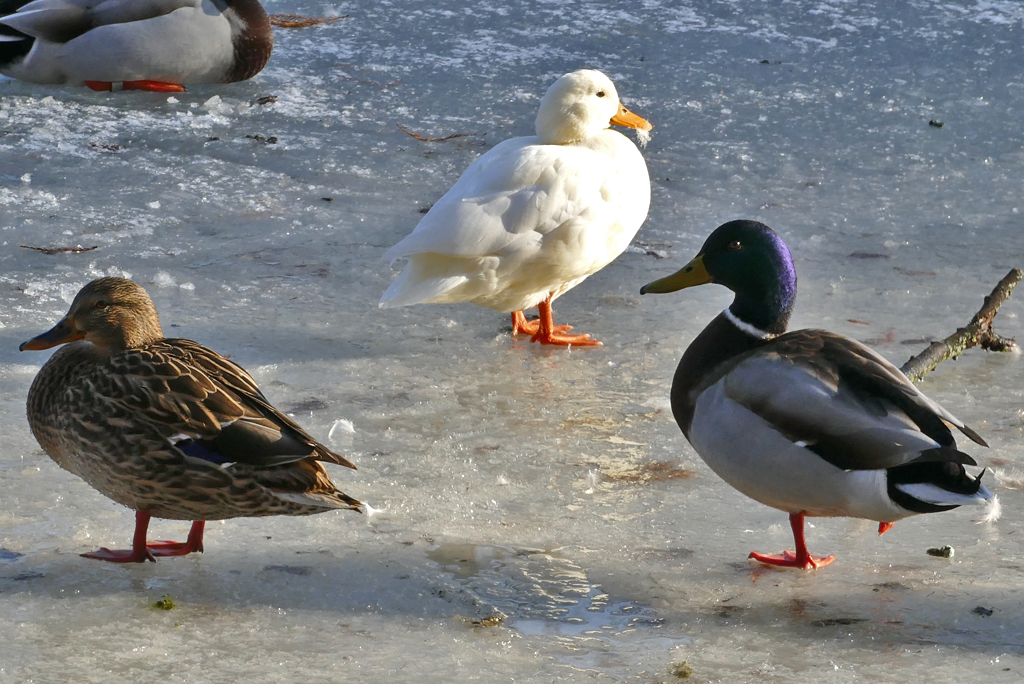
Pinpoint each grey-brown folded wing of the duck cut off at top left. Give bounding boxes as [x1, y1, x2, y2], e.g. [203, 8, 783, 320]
[0, 0, 195, 43]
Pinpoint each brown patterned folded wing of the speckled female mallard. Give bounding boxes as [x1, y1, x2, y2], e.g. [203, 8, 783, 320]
[75, 339, 355, 468]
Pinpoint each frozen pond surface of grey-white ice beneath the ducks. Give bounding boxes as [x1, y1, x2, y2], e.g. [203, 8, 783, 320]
[0, 0, 1024, 684]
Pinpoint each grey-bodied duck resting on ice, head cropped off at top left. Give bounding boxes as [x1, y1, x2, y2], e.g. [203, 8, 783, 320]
[0, 0, 273, 92]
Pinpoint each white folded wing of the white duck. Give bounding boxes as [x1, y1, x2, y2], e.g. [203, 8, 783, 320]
[384, 138, 618, 260]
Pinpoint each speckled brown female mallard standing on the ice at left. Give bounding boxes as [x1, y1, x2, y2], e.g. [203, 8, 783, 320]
[20, 277, 361, 563]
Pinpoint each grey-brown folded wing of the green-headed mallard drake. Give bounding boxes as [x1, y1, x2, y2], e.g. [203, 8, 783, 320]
[723, 331, 984, 470]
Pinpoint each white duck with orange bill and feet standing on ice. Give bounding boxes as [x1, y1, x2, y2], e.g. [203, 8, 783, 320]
[380, 70, 651, 345]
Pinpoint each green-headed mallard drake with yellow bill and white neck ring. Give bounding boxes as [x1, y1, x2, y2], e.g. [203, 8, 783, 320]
[640, 221, 992, 569]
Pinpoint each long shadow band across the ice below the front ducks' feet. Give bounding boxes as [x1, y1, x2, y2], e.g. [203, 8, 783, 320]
[0, 533, 1024, 654]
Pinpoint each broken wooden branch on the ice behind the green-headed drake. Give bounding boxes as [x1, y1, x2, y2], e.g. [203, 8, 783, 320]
[900, 268, 1024, 382]
